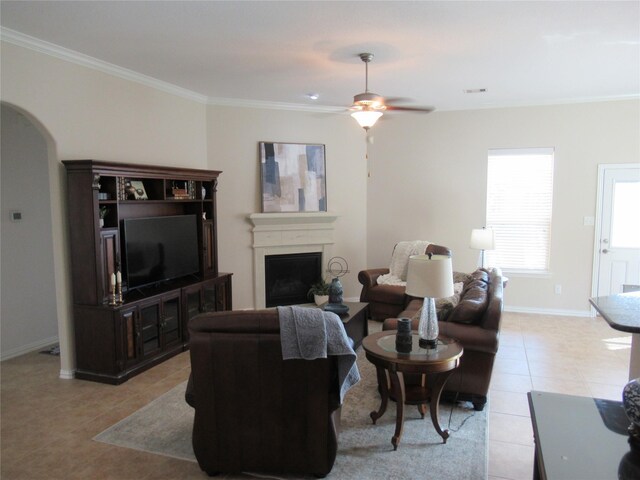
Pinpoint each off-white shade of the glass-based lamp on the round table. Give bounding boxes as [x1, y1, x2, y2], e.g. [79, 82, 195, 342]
[406, 255, 453, 298]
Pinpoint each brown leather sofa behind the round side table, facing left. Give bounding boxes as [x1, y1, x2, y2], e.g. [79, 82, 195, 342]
[382, 268, 504, 410]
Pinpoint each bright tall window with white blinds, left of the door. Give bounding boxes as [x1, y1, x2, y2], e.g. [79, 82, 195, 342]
[486, 148, 553, 273]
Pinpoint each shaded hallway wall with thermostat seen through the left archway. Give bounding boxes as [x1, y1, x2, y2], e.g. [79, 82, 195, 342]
[0, 105, 58, 359]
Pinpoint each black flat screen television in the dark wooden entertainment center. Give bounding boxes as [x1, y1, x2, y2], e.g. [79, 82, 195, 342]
[123, 215, 200, 288]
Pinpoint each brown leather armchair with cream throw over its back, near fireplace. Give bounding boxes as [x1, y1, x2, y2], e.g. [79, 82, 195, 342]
[358, 244, 451, 321]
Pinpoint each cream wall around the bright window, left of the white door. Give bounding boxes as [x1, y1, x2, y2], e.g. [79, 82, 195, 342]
[367, 100, 640, 314]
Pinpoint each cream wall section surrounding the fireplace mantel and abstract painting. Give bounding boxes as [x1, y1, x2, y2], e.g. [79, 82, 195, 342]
[207, 106, 367, 309]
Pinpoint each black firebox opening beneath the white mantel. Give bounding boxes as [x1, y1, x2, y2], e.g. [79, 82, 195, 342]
[264, 252, 322, 307]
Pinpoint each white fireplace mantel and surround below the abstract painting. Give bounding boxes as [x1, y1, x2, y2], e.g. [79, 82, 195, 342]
[248, 212, 338, 308]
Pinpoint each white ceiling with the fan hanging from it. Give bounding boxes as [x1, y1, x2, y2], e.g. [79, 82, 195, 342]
[0, 0, 640, 110]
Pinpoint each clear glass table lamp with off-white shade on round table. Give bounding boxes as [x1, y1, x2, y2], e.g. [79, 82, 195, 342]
[405, 254, 453, 348]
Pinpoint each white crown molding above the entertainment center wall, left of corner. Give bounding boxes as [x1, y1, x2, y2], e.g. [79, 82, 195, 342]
[0, 28, 207, 104]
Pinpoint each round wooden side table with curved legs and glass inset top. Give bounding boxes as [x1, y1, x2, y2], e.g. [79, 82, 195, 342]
[362, 330, 463, 450]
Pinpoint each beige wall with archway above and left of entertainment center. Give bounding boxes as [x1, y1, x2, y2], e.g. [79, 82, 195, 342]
[0, 42, 207, 376]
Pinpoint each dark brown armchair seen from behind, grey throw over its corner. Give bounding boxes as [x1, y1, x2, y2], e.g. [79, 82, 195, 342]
[186, 309, 340, 477]
